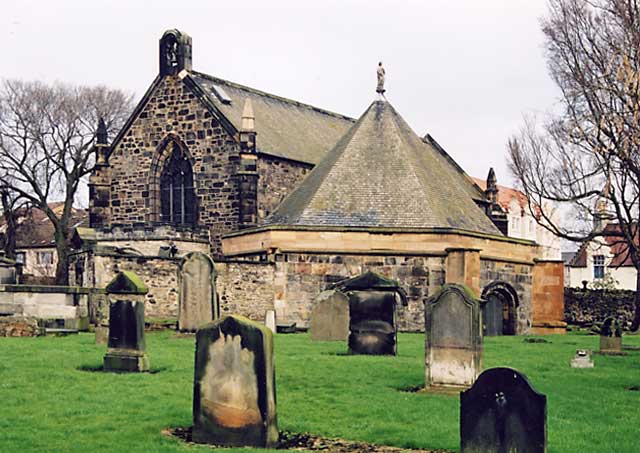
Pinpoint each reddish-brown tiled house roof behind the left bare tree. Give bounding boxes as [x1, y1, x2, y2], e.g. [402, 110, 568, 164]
[0, 202, 89, 248]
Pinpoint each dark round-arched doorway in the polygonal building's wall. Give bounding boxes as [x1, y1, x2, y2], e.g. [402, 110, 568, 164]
[482, 281, 518, 337]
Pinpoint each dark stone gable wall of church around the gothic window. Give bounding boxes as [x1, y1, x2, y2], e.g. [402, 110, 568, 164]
[109, 76, 239, 254]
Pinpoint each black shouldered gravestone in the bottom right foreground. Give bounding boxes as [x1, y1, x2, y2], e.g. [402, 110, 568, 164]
[460, 368, 547, 453]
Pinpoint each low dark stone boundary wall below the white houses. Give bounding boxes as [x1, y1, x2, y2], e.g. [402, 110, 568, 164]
[564, 288, 636, 330]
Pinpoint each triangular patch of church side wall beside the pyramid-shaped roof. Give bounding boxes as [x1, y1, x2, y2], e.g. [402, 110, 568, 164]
[258, 154, 313, 220]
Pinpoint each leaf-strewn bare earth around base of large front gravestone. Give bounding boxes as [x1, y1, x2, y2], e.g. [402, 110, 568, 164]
[162, 426, 451, 453]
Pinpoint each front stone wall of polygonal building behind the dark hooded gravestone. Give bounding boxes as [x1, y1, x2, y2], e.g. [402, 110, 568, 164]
[274, 253, 445, 332]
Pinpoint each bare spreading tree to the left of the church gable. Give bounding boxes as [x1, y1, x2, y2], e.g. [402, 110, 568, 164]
[0, 80, 132, 284]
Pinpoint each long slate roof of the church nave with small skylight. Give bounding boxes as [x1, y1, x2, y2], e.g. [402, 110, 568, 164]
[189, 71, 355, 164]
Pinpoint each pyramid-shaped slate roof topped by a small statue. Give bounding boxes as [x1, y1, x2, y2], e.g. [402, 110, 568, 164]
[265, 101, 502, 235]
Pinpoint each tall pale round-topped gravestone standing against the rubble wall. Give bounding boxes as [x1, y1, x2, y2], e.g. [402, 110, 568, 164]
[178, 252, 218, 332]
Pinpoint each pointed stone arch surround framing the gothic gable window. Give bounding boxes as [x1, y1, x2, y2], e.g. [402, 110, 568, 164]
[147, 133, 199, 224]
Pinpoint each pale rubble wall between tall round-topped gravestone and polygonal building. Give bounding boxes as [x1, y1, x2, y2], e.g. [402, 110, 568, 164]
[215, 261, 280, 323]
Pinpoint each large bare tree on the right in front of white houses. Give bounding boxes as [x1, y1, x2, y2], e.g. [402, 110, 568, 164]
[508, 0, 640, 330]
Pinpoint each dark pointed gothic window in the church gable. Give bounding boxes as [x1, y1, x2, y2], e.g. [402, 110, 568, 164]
[160, 144, 197, 225]
